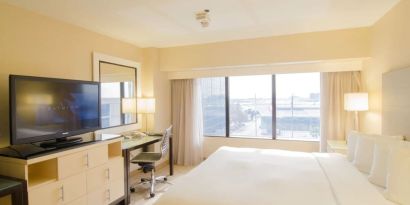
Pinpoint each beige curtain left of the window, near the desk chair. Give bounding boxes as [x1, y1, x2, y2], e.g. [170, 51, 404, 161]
[171, 79, 203, 165]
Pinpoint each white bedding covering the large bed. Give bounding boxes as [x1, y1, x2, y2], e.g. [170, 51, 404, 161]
[156, 147, 394, 205]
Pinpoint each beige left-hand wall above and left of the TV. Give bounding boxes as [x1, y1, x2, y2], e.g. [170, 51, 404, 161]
[0, 3, 144, 146]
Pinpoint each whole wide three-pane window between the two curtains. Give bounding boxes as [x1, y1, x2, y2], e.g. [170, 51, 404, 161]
[201, 73, 320, 140]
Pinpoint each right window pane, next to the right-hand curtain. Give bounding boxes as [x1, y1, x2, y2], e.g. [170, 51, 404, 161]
[276, 73, 320, 140]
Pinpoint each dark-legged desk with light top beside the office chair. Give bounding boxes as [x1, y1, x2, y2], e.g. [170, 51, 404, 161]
[121, 136, 174, 204]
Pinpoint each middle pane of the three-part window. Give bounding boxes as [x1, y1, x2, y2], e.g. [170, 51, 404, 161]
[229, 75, 272, 139]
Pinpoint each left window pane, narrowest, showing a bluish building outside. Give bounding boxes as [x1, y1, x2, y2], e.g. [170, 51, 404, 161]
[200, 77, 226, 136]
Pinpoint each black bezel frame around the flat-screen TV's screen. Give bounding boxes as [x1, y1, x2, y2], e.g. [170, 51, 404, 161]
[9, 75, 101, 145]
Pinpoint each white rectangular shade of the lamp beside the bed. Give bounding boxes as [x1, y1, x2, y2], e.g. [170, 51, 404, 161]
[344, 93, 369, 111]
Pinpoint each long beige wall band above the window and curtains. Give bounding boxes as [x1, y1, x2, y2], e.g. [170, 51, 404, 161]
[160, 28, 370, 71]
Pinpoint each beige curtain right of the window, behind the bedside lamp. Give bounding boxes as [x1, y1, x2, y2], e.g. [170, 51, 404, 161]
[320, 71, 361, 152]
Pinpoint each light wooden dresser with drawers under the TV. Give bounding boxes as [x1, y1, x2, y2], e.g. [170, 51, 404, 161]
[0, 138, 124, 205]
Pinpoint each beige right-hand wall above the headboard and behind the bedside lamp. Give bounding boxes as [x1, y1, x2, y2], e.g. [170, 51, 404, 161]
[361, 0, 410, 133]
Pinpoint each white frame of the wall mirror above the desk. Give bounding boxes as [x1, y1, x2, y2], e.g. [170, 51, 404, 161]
[93, 52, 141, 132]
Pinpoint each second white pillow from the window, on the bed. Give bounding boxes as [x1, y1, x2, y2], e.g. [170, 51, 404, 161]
[353, 136, 374, 173]
